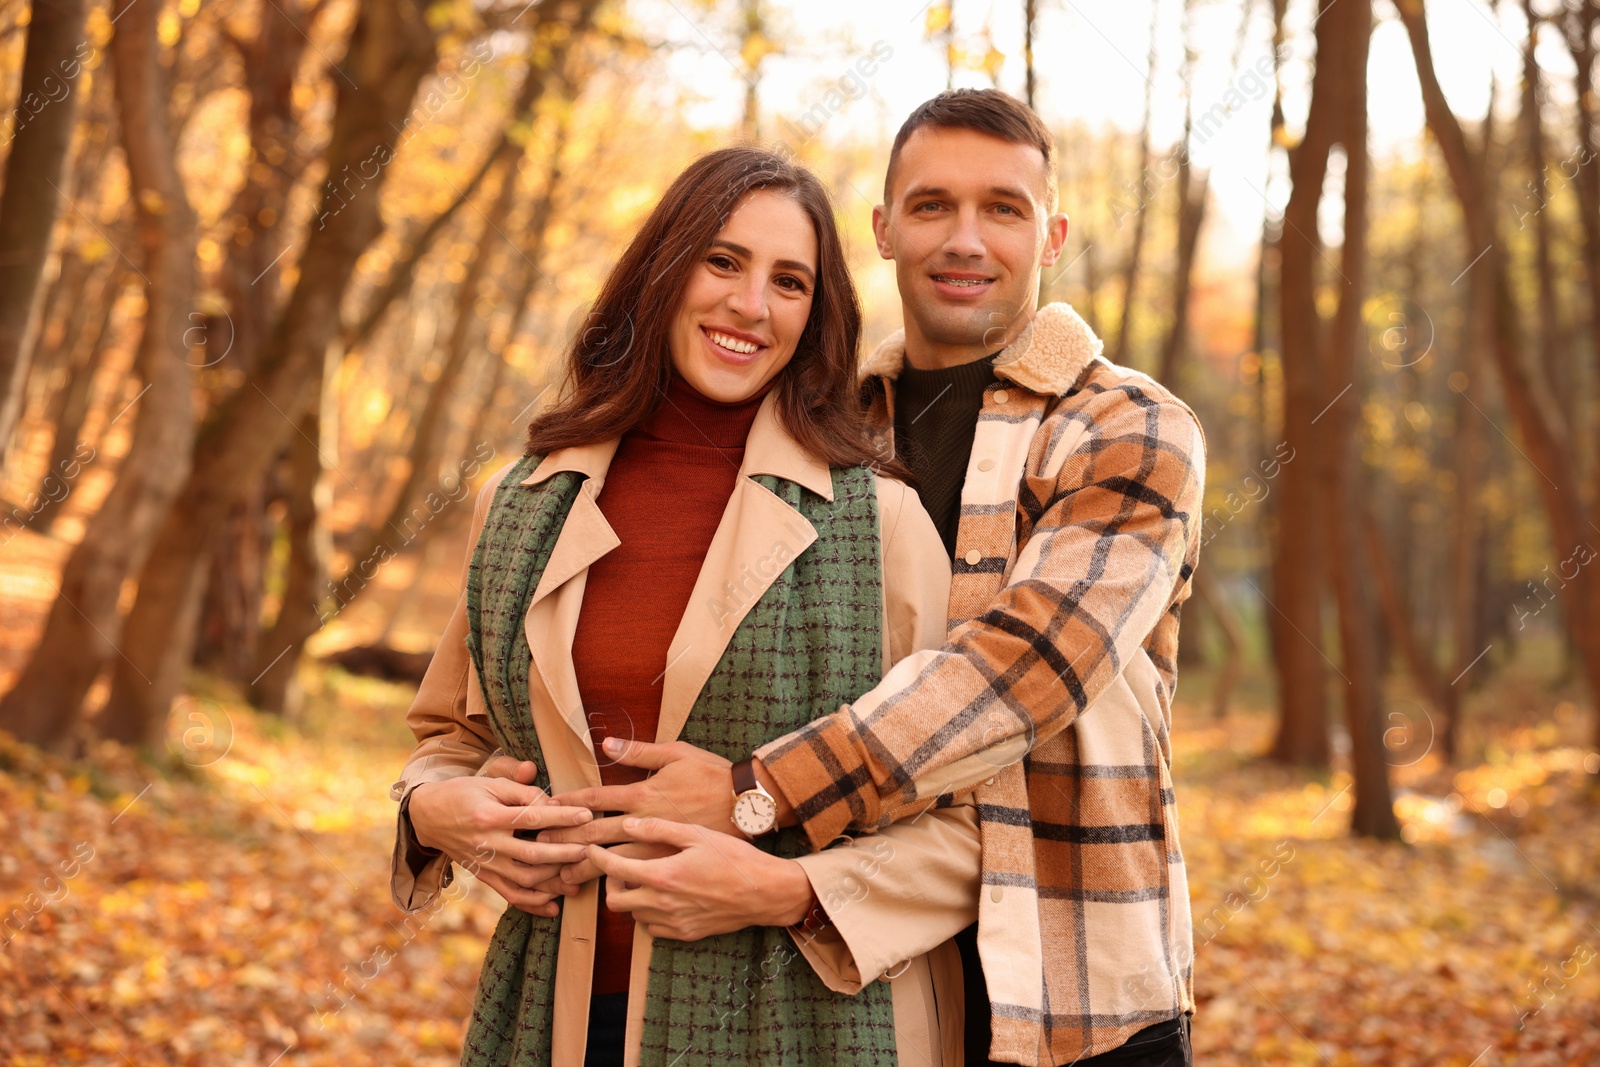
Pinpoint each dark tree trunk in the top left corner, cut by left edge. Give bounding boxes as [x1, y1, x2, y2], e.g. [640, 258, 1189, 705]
[0, 0, 90, 469]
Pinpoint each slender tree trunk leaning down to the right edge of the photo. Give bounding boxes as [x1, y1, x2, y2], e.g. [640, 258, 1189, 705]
[1395, 0, 1600, 744]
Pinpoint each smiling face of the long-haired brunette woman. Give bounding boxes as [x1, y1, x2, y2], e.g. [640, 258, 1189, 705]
[670, 189, 816, 403]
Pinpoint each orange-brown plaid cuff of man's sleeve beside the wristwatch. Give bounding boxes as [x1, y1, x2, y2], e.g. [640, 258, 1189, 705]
[755, 707, 880, 851]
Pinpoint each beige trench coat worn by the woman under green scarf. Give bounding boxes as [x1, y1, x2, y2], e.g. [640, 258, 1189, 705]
[390, 394, 979, 1067]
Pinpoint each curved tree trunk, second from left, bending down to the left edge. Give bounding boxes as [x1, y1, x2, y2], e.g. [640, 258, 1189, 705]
[0, 5, 195, 749]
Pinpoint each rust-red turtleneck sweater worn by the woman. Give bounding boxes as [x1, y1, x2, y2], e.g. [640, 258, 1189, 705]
[573, 374, 766, 993]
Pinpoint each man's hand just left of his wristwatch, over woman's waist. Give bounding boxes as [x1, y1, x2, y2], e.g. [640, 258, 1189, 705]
[539, 737, 744, 851]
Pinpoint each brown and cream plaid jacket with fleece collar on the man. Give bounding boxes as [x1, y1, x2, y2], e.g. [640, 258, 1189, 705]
[758, 304, 1205, 1064]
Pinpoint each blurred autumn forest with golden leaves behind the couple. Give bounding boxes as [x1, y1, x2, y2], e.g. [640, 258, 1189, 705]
[0, 0, 1600, 1067]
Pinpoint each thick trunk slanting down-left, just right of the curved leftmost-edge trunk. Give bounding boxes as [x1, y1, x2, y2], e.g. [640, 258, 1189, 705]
[106, 0, 435, 733]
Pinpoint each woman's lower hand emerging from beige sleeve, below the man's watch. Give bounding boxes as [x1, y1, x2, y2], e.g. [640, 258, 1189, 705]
[589, 817, 813, 941]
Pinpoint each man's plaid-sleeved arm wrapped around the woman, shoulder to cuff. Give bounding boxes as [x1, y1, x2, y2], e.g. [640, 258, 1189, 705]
[757, 386, 1205, 848]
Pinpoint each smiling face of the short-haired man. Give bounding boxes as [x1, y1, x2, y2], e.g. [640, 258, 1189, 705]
[872, 126, 1067, 366]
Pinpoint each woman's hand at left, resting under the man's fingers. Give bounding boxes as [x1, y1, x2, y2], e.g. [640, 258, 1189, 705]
[406, 761, 594, 917]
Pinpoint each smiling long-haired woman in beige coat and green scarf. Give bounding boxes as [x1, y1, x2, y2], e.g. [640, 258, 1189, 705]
[394, 147, 978, 1065]
